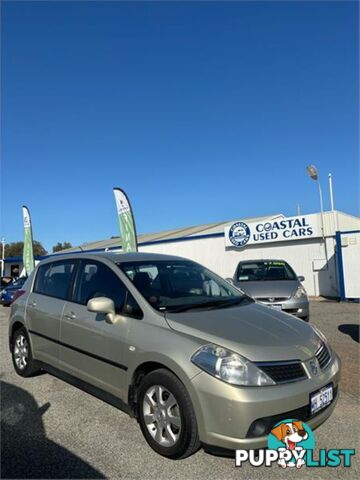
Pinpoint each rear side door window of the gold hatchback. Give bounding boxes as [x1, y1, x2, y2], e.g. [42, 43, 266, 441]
[34, 260, 75, 300]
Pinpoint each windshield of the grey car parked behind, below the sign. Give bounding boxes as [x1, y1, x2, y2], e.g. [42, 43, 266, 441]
[237, 260, 297, 282]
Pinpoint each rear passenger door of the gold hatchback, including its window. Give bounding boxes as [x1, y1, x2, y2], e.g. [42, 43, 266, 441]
[26, 260, 76, 367]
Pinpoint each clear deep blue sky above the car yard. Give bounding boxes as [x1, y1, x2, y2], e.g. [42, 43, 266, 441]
[0, 2, 359, 250]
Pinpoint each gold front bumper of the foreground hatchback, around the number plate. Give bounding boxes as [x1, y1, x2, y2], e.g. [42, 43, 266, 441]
[191, 352, 340, 450]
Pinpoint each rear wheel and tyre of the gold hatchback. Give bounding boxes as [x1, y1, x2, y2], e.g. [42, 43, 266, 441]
[11, 327, 40, 377]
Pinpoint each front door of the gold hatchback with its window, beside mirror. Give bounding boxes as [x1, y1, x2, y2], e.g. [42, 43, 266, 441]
[59, 259, 138, 400]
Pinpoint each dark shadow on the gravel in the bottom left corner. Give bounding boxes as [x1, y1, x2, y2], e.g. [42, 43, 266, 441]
[0, 381, 106, 478]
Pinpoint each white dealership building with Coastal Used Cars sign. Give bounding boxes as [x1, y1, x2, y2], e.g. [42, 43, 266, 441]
[5, 211, 360, 299]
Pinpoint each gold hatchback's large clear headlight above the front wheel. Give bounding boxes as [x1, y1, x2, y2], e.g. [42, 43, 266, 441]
[191, 343, 275, 386]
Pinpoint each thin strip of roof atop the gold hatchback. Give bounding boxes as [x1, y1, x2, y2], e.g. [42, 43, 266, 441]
[41, 252, 186, 263]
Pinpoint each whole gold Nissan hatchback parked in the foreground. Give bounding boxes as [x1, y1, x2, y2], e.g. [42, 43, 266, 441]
[9, 253, 340, 459]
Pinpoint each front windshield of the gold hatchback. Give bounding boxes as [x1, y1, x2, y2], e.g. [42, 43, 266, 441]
[119, 260, 251, 312]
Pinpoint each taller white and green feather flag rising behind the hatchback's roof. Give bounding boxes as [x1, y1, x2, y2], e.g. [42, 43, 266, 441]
[113, 188, 138, 253]
